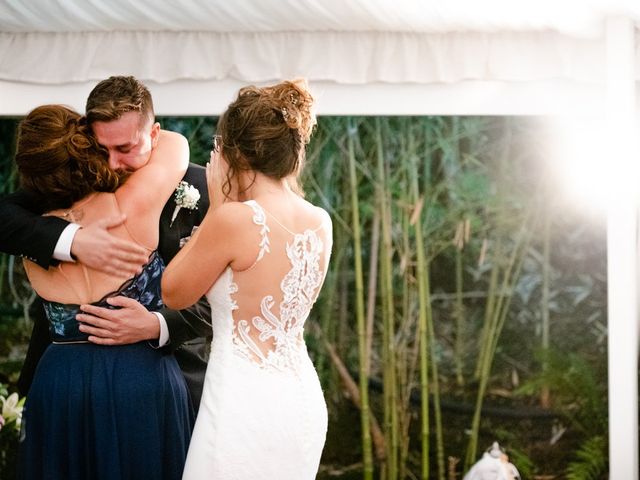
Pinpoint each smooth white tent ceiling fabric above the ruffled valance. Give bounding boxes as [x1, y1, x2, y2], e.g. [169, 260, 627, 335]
[0, 0, 639, 36]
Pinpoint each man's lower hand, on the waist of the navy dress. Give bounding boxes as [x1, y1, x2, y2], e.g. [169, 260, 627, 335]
[76, 297, 160, 345]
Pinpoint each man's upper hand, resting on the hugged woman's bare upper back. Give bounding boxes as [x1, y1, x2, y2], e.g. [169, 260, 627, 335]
[71, 215, 149, 277]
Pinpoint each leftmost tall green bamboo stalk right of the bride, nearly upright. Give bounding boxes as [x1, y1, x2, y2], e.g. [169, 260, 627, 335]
[347, 119, 373, 480]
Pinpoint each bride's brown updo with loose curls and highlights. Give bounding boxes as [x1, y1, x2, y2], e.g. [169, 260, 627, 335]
[217, 80, 316, 195]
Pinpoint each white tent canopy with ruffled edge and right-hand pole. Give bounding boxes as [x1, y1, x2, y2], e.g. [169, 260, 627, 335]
[0, 0, 640, 480]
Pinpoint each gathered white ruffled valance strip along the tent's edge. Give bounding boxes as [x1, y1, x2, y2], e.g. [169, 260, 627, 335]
[0, 31, 608, 84]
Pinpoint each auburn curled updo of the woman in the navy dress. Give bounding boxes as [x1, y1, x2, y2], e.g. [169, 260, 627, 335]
[15, 105, 124, 210]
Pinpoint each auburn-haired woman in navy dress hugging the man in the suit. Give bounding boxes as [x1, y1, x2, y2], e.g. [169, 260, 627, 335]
[16, 105, 193, 480]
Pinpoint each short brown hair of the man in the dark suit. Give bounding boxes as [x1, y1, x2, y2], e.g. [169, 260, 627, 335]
[86, 76, 155, 125]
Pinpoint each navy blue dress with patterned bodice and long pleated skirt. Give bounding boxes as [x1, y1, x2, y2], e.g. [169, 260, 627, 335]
[19, 252, 194, 480]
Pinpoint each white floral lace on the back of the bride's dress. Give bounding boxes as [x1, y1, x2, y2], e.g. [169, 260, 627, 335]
[229, 200, 323, 372]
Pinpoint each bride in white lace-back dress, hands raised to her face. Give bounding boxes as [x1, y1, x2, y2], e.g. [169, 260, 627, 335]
[162, 81, 332, 480]
